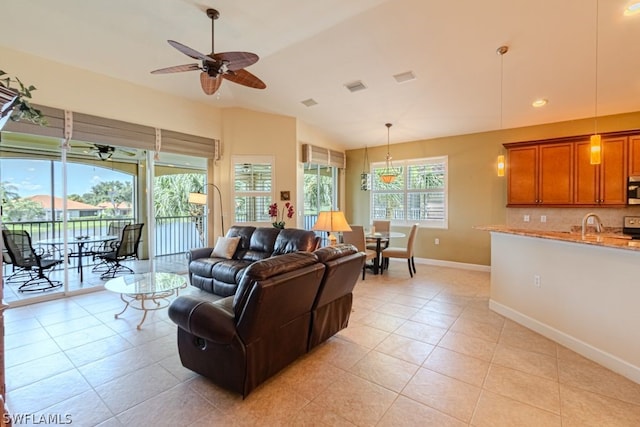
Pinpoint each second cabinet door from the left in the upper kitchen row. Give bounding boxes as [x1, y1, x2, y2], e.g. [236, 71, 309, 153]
[538, 142, 574, 205]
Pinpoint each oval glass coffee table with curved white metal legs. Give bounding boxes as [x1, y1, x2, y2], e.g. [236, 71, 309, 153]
[104, 272, 187, 330]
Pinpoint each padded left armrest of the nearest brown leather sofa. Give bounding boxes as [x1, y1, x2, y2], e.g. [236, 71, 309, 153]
[169, 295, 236, 344]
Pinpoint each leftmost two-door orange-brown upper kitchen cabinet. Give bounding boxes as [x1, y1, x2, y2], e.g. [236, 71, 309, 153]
[507, 142, 574, 206]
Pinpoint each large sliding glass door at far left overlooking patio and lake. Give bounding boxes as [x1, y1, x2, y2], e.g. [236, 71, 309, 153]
[0, 132, 144, 305]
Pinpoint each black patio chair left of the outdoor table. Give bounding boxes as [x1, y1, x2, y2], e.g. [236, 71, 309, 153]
[2, 230, 62, 292]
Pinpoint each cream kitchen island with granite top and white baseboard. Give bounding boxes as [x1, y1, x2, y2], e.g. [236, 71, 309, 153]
[481, 226, 640, 383]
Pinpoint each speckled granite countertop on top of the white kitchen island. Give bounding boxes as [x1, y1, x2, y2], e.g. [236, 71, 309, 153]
[475, 225, 640, 251]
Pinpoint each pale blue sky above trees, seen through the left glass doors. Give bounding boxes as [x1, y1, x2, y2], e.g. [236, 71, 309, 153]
[0, 158, 131, 197]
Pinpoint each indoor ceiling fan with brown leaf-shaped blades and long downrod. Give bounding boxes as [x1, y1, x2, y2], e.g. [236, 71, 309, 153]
[151, 9, 267, 95]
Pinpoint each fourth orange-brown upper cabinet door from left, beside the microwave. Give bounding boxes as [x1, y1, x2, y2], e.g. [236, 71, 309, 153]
[600, 137, 628, 205]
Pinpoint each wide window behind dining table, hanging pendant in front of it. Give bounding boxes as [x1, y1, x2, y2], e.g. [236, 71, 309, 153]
[371, 156, 448, 228]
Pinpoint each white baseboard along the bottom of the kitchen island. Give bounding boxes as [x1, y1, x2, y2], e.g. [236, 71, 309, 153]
[489, 300, 640, 384]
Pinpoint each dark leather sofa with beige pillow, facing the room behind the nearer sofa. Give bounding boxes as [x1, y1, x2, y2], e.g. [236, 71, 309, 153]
[187, 225, 319, 297]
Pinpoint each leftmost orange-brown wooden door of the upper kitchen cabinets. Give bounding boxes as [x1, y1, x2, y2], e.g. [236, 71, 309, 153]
[507, 146, 538, 205]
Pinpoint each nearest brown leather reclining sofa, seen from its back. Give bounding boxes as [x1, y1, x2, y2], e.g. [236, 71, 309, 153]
[169, 245, 364, 397]
